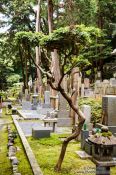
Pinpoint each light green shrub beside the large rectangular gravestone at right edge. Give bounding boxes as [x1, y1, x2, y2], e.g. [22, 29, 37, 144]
[79, 98, 102, 123]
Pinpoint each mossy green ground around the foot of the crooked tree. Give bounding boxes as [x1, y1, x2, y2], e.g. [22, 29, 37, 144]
[28, 134, 95, 175]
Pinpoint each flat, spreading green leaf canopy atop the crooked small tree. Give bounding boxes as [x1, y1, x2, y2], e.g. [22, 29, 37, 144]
[15, 25, 102, 55]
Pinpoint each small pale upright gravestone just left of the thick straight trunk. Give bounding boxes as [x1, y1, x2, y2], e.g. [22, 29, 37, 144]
[42, 91, 51, 108]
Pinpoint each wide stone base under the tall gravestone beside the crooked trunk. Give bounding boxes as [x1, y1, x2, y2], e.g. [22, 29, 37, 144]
[57, 118, 72, 127]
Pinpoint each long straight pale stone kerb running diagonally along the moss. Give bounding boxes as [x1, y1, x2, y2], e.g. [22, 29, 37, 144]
[12, 116, 43, 175]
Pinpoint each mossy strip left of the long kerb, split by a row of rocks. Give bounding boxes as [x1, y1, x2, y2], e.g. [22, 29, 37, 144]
[0, 109, 33, 175]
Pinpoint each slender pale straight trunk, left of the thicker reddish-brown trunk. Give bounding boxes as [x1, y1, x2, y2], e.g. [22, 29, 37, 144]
[36, 0, 42, 89]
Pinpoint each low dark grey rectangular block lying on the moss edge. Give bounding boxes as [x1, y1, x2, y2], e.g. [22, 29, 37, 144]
[32, 127, 51, 139]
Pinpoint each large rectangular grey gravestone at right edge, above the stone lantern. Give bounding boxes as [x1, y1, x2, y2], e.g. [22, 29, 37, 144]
[102, 95, 116, 126]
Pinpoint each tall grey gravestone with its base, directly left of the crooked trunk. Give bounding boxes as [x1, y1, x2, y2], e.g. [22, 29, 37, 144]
[57, 94, 72, 127]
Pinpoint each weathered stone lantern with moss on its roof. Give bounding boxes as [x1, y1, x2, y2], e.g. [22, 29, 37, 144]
[88, 126, 116, 175]
